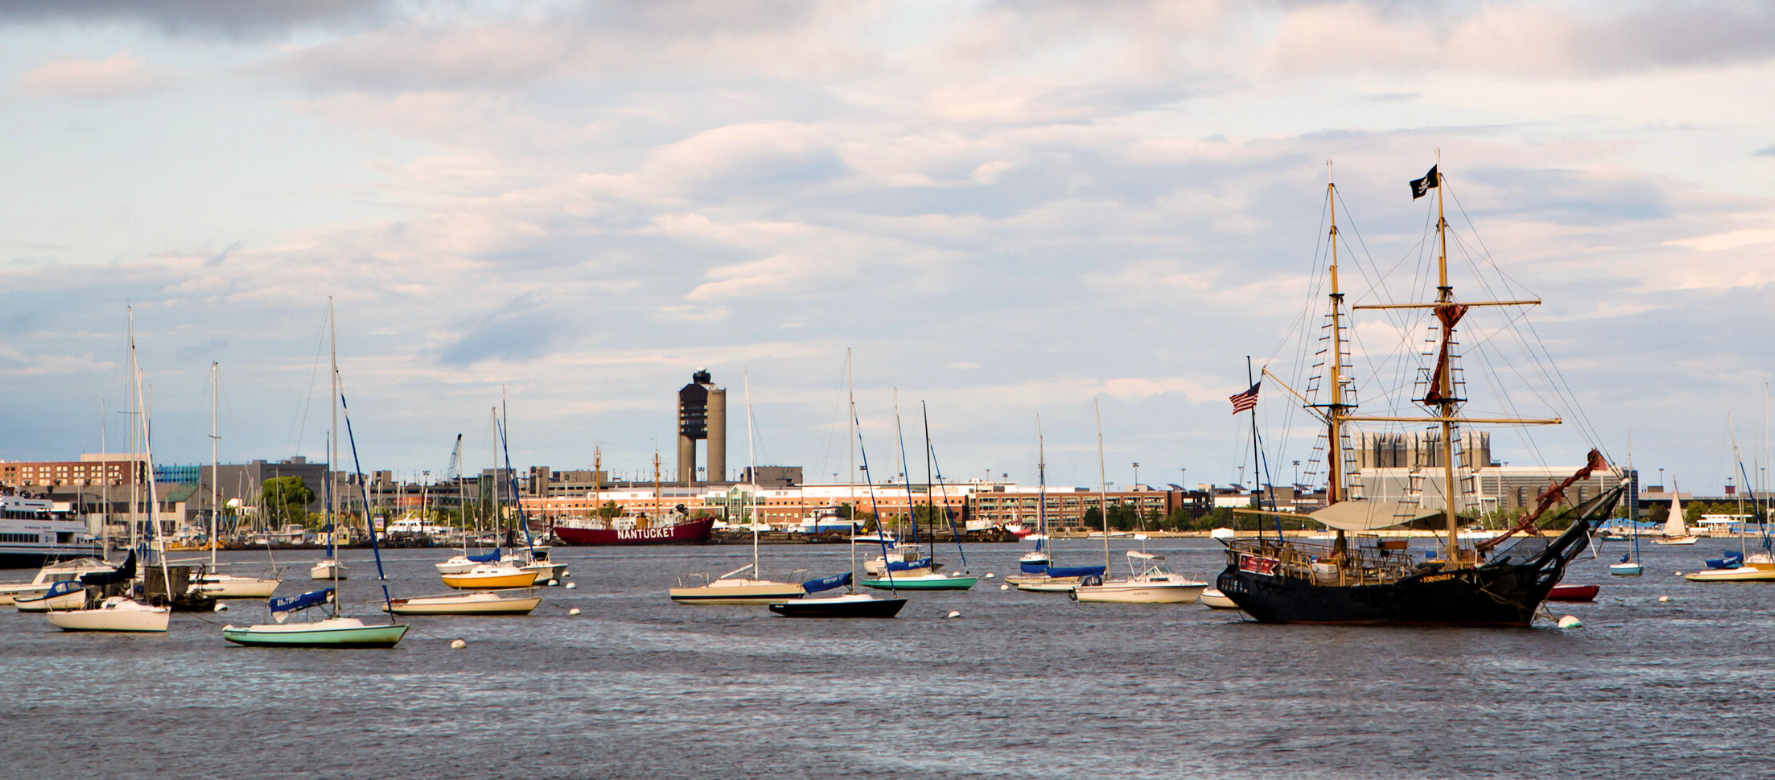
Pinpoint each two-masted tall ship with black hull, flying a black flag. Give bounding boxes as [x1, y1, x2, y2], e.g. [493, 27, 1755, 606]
[1216, 159, 1621, 627]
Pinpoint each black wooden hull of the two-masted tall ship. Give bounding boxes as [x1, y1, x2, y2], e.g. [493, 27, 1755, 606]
[1216, 501, 1613, 627]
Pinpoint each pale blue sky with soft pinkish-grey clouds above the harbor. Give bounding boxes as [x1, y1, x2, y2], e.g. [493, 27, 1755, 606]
[0, 0, 1775, 492]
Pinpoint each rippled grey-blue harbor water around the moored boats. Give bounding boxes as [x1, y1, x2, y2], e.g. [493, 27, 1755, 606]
[0, 538, 1775, 780]
